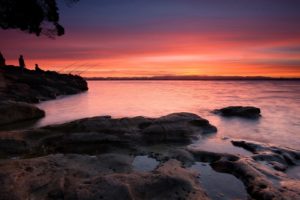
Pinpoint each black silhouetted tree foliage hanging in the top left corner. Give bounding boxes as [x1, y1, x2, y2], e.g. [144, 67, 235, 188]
[0, 0, 79, 37]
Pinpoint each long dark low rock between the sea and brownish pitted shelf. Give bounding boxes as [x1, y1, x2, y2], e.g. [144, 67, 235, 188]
[0, 113, 217, 156]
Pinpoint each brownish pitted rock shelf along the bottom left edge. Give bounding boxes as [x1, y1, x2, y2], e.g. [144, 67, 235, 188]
[0, 158, 208, 200]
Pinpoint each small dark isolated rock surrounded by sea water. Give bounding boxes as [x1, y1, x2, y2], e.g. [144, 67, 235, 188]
[213, 106, 261, 118]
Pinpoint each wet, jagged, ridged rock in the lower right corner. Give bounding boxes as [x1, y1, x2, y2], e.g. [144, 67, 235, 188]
[188, 141, 300, 200]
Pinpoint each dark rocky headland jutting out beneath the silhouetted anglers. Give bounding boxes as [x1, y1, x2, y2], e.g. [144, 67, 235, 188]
[0, 66, 88, 126]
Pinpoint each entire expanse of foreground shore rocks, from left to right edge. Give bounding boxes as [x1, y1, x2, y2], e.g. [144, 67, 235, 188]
[0, 113, 300, 200]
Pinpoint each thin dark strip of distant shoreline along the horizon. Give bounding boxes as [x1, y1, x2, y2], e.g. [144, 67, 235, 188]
[84, 76, 300, 81]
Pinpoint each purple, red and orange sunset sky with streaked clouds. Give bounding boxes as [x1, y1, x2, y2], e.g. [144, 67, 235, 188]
[0, 0, 300, 77]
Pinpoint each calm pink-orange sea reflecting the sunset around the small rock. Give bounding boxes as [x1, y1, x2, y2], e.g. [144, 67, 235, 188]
[33, 81, 300, 151]
